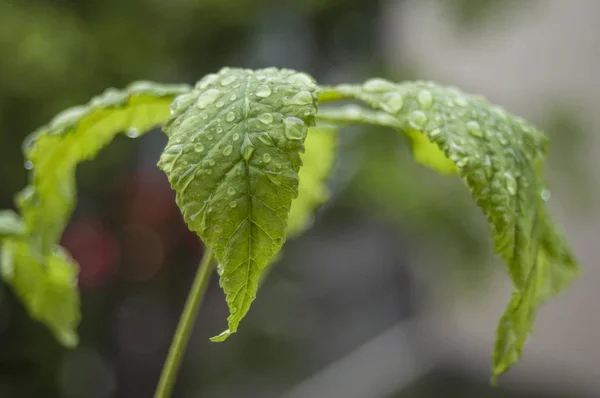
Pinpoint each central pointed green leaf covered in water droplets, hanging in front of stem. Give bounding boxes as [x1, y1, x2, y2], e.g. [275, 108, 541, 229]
[159, 68, 317, 341]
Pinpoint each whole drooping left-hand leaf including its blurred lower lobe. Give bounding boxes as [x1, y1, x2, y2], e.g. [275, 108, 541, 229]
[0, 82, 188, 346]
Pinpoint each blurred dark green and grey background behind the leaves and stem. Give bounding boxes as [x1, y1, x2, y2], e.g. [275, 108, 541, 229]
[0, 0, 600, 398]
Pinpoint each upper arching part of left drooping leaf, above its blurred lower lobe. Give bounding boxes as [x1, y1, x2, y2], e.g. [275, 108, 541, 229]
[17, 82, 188, 252]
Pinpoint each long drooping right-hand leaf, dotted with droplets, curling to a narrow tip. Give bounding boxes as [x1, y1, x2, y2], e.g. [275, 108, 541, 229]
[319, 79, 579, 377]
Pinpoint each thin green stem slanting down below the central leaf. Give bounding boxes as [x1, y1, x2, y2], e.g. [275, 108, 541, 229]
[154, 247, 214, 398]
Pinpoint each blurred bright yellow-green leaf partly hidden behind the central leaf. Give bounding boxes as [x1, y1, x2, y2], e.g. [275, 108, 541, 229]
[287, 126, 338, 238]
